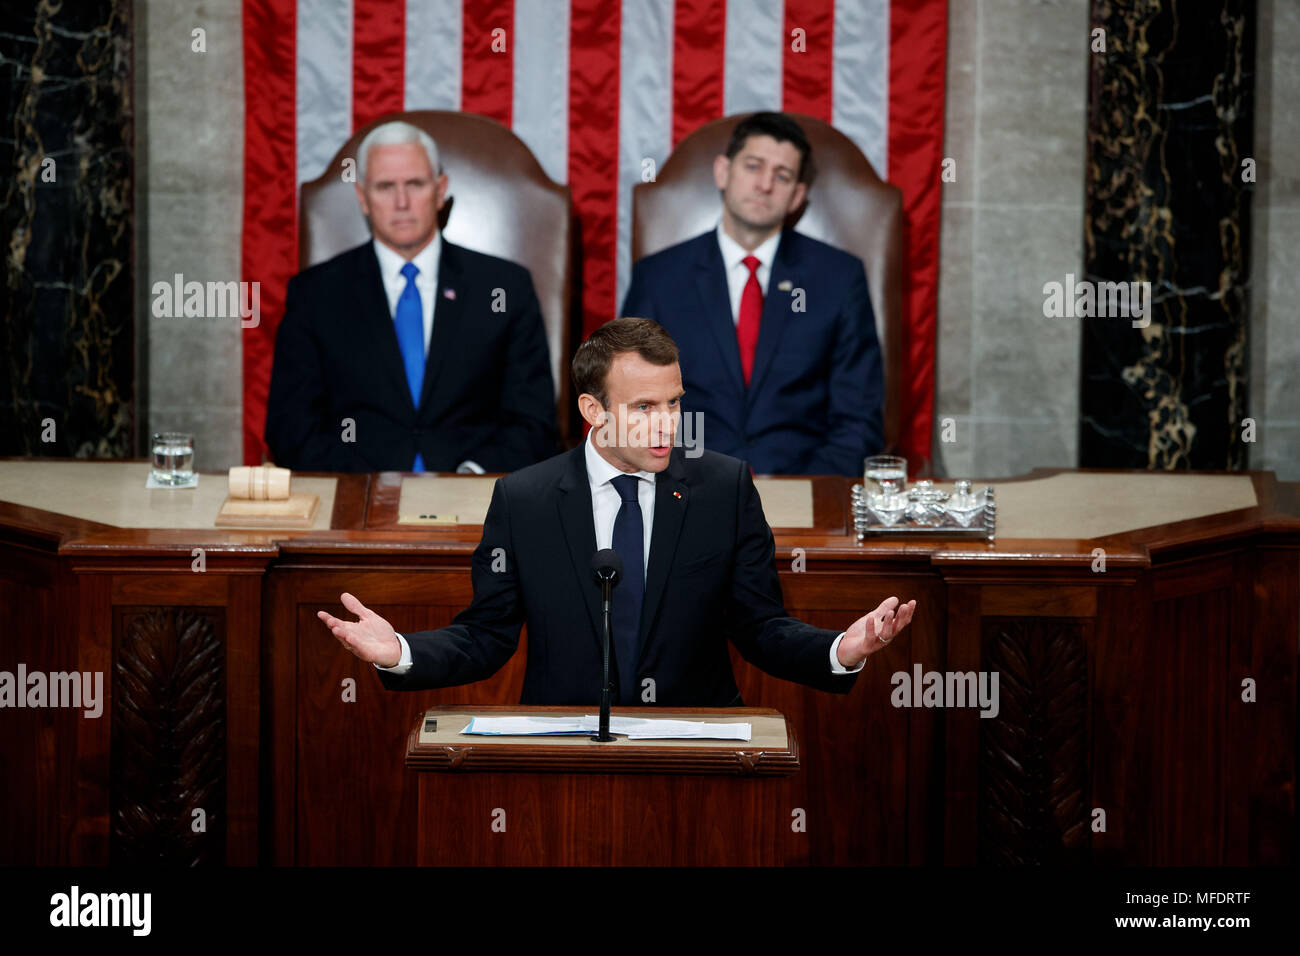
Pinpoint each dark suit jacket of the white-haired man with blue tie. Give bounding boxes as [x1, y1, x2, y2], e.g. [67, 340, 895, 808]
[267, 238, 555, 472]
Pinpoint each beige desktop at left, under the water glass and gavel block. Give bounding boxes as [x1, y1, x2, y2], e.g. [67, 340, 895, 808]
[0, 460, 338, 531]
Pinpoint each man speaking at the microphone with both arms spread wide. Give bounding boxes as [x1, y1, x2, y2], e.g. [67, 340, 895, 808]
[317, 319, 917, 708]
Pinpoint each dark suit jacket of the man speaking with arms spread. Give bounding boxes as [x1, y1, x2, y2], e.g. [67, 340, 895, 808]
[378, 445, 857, 706]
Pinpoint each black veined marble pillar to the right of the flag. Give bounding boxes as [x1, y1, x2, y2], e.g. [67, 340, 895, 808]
[1079, 0, 1256, 471]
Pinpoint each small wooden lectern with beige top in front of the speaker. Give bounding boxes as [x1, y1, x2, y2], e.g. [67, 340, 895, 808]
[406, 706, 807, 866]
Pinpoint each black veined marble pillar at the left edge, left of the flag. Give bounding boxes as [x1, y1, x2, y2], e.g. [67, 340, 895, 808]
[0, 0, 134, 458]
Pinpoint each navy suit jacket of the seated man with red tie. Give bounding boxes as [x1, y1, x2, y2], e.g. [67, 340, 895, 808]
[621, 229, 884, 475]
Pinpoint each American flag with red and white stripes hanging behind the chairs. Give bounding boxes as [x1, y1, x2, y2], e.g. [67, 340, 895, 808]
[241, 0, 948, 464]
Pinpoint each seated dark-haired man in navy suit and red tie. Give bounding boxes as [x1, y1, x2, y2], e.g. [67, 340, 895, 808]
[621, 113, 884, 475]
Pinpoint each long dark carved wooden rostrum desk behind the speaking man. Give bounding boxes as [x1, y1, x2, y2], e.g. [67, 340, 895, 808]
[0, 462, 1300, 865]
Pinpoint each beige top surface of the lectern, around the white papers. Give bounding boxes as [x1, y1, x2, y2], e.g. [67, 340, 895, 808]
[419, 708, 789, 750]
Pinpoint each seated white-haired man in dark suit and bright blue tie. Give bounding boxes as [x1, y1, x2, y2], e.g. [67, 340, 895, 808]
[265, 122, 555, 472]
